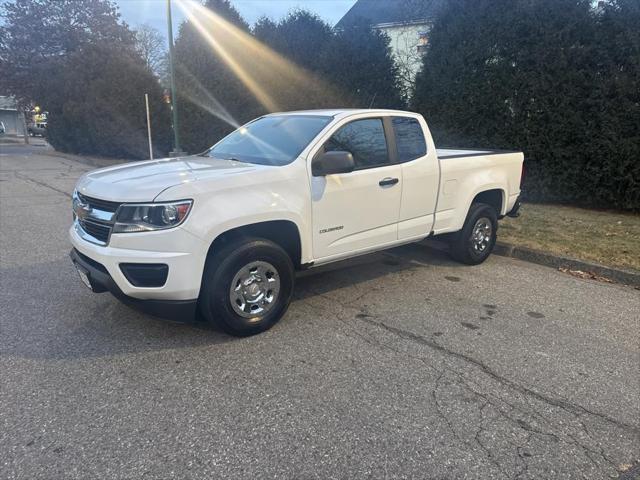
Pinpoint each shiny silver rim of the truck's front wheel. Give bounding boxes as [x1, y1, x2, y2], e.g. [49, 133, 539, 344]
[229, 261, 280, 320]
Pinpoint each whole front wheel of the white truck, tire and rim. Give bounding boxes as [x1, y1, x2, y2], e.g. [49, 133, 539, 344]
[200, 238, 294, 336]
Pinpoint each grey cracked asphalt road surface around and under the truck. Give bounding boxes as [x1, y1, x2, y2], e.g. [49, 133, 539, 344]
[0, 145, 640, 479]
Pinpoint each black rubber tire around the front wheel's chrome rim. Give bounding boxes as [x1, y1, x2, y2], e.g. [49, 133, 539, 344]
[200, 238, 295, 337]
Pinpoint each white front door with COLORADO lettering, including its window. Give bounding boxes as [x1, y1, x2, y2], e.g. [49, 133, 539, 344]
[311, 118, 402, 261]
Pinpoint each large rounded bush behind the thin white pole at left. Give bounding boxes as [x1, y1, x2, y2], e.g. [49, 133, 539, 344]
[42, 45, 171, 159]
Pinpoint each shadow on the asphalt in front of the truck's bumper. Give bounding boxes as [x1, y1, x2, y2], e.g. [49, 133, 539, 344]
[0, 258, 234, 359]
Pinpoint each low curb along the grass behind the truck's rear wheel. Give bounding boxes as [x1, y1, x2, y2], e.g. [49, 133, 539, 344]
[493, 242, 640, 287]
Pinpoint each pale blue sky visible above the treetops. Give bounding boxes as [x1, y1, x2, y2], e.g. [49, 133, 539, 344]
[114, 0, 355, 37]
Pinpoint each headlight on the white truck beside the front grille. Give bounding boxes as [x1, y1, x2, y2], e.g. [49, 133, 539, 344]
[113, 200, 193, 233]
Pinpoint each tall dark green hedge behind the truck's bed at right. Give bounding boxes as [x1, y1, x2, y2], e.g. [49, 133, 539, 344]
[414, 0, 640, 210]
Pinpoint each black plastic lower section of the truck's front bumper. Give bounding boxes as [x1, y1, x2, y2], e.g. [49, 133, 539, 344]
[69, 248, 198, 322]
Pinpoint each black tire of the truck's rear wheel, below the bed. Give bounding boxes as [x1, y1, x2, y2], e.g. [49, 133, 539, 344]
[450, 203, 498, 265]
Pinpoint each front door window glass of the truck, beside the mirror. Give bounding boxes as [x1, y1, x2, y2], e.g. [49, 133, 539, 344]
[324, 118, 389, 169]
